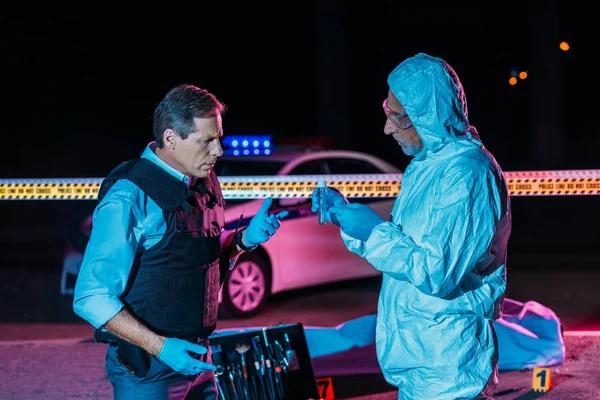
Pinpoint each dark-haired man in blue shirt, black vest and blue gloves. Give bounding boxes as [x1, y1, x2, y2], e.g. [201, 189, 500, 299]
[73, 85, 287, 400]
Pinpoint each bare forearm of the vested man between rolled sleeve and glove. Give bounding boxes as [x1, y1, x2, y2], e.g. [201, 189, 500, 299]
[106, 308, 166, 356]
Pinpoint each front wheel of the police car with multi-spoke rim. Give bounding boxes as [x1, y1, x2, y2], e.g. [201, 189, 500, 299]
[223, 253, 271, 318]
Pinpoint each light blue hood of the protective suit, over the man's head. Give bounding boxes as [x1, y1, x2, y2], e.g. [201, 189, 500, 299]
[388, 53, 480, 158]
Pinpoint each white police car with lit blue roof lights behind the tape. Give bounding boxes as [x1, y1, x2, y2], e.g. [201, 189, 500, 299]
[215, 136, 401, 318]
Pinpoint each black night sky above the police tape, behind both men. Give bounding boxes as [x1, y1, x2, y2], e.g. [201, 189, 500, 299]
[0, 0, 598, 178]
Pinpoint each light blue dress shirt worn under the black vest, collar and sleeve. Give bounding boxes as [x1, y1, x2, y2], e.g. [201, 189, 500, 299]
[73, 142, 195, 328]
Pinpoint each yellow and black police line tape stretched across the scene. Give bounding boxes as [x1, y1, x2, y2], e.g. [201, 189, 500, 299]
[0, 170, 600, 200]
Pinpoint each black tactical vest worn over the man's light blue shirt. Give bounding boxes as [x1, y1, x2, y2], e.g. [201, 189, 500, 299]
[98, 158, 225, 338]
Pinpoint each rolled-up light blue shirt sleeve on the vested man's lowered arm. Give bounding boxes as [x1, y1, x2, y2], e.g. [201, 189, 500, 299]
[73, 193, 142, 328]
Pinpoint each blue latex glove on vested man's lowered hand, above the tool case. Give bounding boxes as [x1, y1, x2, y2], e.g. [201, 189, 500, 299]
[156, 338, 217, 375]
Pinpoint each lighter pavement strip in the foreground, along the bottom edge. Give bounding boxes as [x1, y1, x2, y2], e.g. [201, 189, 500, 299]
[0, 336, 600, 400]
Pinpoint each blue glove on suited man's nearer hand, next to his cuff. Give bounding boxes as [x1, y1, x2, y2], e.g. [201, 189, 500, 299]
[329, 203, 384, 240]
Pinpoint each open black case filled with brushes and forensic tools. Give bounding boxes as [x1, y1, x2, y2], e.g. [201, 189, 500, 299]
[209, 323, 319, 400]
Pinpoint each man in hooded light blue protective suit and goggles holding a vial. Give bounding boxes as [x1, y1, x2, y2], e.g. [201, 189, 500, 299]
[312, 53, 511, 400]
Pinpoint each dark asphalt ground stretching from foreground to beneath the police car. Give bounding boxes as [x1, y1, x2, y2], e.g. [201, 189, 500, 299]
[0, 269, 600, 400]
